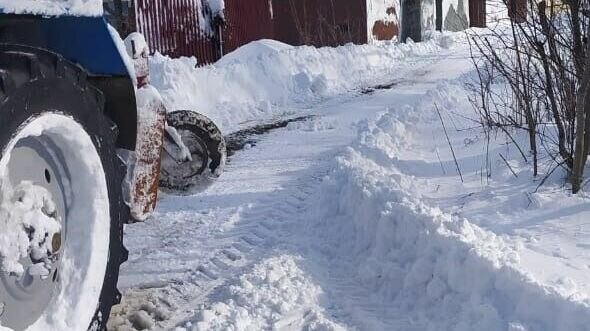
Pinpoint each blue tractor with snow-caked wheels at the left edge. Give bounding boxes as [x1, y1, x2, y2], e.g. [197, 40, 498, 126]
[0, 0, 226, 331]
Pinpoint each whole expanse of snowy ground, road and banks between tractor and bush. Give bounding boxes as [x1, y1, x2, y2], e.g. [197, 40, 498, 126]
[110, 34, 590, 331]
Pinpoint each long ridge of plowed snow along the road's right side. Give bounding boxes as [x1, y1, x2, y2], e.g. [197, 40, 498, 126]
[298, 87, 590, 331]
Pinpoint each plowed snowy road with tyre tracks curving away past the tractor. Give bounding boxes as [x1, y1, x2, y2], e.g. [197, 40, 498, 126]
[110, 51, 456, 330]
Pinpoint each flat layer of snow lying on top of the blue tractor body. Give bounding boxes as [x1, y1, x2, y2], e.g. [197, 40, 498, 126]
[0, 0, 103, 16]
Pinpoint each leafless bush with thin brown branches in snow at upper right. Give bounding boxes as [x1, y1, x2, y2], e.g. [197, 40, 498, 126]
[469, 0, 590, 193]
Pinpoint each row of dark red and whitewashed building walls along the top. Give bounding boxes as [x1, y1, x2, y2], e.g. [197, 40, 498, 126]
[111, 0, 526, 64]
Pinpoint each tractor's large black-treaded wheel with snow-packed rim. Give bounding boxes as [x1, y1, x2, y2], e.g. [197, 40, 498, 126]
[0, 44, 129, 331]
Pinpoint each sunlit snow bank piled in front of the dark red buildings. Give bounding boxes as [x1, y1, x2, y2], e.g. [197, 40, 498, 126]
[150, 34, 448, 132]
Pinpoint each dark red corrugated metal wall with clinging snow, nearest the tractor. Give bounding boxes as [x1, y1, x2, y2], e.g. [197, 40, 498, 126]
[136, 0, 274, 65]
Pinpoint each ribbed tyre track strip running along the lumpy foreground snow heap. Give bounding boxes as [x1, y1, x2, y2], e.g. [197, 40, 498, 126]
[109, 125, 338, 331]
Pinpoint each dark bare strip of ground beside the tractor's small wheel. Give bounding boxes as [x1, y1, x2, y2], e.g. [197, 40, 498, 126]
[225, 115, 313, 158]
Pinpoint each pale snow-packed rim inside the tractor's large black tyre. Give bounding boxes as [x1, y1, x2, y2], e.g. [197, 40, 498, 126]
[0, 113, 110, 330]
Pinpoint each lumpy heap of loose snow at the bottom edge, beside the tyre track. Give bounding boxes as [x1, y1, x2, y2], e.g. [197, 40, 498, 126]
[186, 255, 345, 331]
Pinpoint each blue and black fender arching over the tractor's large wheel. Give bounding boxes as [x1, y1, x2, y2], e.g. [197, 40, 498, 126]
[0, 12, 137, 150]
